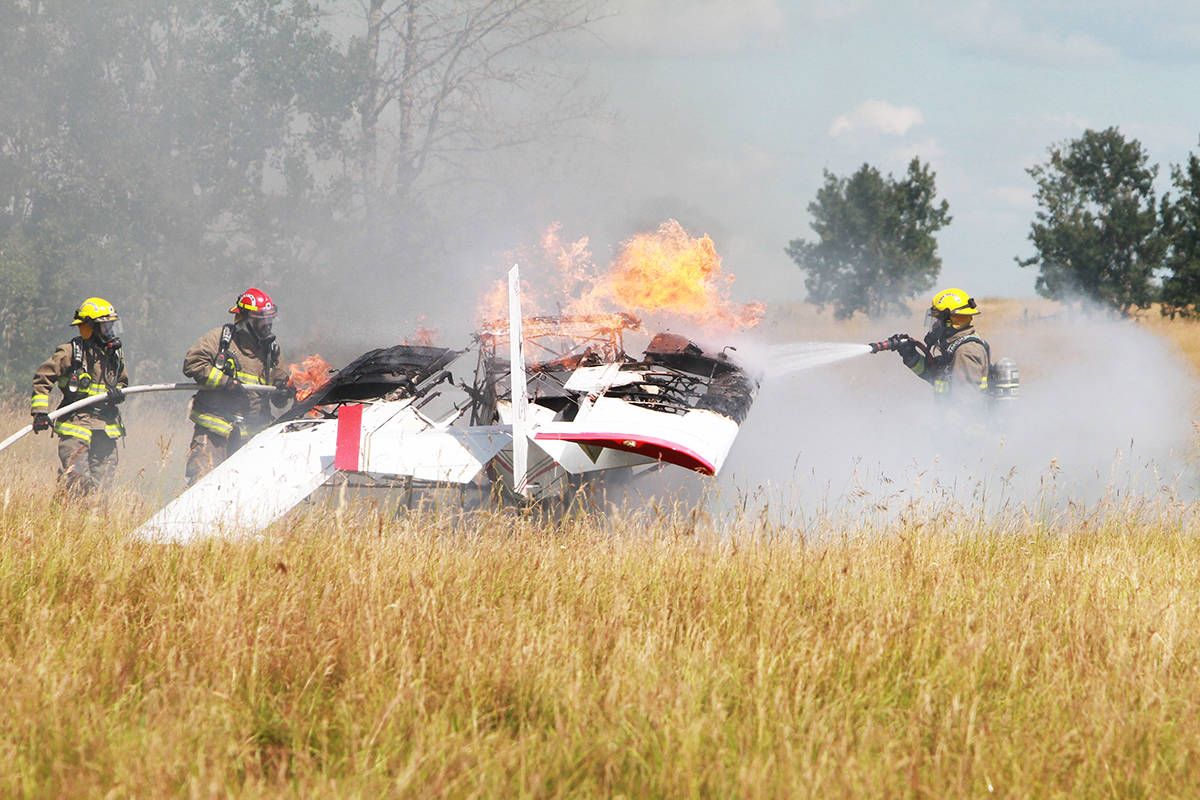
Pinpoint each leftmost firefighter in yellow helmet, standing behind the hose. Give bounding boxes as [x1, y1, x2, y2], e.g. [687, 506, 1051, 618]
[29, 297, 130, 494]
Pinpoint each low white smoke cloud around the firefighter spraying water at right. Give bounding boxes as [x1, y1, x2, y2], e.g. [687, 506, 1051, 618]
[721, 304, 1198, 515]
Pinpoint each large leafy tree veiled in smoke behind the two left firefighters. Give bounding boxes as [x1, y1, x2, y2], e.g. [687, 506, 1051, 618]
[0, 0, 354, 385]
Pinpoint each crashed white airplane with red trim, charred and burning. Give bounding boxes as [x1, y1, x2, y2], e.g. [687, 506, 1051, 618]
[136, 267, 758, 542]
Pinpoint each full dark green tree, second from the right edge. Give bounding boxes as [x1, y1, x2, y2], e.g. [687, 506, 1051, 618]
[1016, 127, 1165, 314]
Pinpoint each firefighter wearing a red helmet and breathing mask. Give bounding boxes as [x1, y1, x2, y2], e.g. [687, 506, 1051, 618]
[184, 289, 295, 486]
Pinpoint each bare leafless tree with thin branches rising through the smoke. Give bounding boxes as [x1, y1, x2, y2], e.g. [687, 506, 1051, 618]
[359, 0, 599, 205]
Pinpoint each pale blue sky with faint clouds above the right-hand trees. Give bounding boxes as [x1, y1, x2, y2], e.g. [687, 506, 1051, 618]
[556, 0, 1200, 299]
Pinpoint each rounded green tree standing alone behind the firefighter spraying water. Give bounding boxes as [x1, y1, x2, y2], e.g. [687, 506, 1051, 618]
[786, 158, 950, 319]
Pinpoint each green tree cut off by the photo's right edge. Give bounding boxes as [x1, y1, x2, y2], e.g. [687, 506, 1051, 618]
[1162, 142, 1200, 317]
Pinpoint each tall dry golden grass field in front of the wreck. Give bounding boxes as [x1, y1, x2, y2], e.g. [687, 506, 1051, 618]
[7, 303, 1200, 798]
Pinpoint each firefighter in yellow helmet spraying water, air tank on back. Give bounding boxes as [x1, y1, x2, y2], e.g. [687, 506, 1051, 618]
[895, 289, 991, 405]
